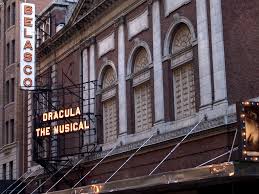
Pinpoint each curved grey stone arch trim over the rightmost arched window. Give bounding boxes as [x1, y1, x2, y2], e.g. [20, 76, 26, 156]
[163, 13, 197, 59]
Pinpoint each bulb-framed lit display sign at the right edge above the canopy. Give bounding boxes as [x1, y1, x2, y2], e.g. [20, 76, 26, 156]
[237, 102, 259, 161]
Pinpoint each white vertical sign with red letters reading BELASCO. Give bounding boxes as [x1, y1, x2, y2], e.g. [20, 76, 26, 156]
[20, 3, 35, 90]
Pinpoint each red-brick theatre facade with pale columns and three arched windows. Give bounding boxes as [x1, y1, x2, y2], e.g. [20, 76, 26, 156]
[24, 0, 259, 193]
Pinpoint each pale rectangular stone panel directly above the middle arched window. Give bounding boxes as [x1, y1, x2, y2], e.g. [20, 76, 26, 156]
[128, 9, 149, 40]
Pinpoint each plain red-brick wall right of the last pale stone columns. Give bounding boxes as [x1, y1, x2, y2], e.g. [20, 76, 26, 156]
[222, 0, 259, 104]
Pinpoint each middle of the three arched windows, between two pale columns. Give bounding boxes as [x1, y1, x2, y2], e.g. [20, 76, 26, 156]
[133, 47, 152, 133]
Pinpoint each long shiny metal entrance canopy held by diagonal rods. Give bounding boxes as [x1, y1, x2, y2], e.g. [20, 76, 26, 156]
[47, 162, 259, 194]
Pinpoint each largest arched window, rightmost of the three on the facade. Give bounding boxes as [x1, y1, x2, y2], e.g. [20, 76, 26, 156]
[171, 24, 195, 120]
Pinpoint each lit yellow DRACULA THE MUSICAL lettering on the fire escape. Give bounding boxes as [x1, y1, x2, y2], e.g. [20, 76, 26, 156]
[36, 107, 89, 137]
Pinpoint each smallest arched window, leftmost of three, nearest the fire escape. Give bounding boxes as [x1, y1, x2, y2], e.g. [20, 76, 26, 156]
[102, 66, 118, 143]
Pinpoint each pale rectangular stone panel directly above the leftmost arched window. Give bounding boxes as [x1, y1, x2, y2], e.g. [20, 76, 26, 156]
[97, 33, 115, 58]
